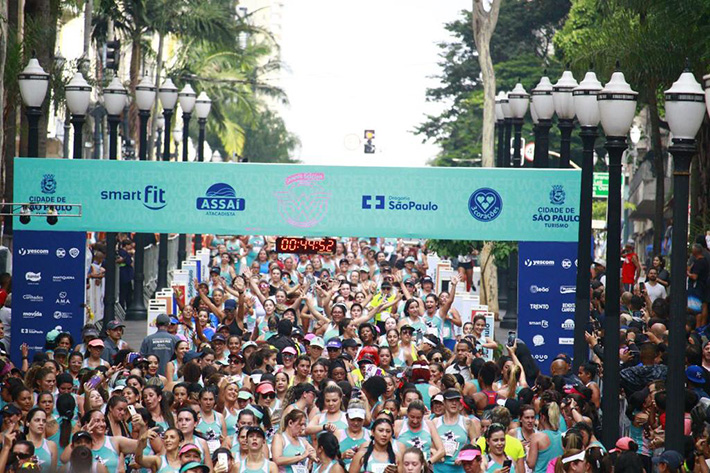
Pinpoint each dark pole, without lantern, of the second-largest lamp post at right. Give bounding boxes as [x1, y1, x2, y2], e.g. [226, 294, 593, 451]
[602, 136, 626, 449]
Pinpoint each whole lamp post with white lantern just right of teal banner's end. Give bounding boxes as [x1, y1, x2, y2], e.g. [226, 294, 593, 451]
[572, 71, 602, 368]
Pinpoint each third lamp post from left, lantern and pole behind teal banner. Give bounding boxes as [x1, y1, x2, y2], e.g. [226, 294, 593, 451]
[102, 77, 128, 332]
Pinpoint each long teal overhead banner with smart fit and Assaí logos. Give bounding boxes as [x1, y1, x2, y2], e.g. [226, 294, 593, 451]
[14, 158, 580, 241]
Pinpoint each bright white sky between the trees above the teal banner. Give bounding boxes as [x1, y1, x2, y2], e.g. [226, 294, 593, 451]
[280, 0, 472, 166]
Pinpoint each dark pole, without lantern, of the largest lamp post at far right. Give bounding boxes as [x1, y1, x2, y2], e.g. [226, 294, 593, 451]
[672, 138, 696, 452]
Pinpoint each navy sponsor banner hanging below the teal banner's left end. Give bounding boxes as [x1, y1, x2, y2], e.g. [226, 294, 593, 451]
[11, 229, 86, 366]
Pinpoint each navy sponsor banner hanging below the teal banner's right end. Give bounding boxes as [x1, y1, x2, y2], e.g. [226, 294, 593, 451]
[518, 242, 577, 374]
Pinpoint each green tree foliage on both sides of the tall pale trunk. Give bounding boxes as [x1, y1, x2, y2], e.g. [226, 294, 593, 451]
[414, 0, 581, 166]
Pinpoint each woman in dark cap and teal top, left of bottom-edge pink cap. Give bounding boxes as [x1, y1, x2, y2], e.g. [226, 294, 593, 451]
[433, 389, 481, 473]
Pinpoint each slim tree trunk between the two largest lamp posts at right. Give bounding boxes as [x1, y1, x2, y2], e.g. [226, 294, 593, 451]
[648, 90, 666, 255]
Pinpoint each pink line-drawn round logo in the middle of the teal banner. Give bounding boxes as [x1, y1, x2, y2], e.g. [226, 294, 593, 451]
[274, 173, 331, 228]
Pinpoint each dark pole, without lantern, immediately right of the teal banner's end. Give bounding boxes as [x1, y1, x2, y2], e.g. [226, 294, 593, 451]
[574, 126, 598, 372]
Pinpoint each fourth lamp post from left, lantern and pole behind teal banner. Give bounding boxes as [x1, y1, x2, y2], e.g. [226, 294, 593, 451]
[126, 76, 155, 320]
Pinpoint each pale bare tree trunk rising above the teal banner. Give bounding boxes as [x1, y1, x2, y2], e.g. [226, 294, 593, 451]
[472, 0, 501, 167]
